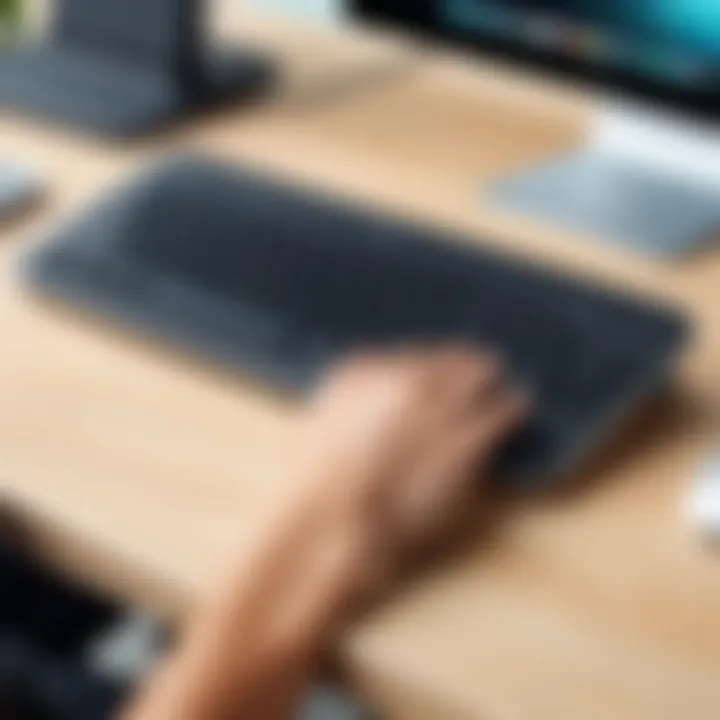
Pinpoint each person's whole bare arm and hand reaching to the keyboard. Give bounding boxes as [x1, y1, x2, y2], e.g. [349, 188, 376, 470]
[126, 347, 529, 720]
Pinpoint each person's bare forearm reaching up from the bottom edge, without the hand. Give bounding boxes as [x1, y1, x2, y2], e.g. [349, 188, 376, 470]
[128, 500, 362, 720]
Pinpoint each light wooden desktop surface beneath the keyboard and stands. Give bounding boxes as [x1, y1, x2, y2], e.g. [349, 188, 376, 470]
[0, 7, 720, 720]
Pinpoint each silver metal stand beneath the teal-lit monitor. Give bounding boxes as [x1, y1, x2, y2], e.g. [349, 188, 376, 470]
[490, 105, 720, 257]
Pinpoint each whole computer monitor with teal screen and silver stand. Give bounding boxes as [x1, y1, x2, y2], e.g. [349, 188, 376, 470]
[353, 0, 720, 255]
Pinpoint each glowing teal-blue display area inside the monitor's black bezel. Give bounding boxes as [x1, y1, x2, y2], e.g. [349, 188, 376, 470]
[441, 0, 720, 93]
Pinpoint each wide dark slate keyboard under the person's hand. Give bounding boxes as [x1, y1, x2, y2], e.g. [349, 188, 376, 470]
[27, 159, 687, 484]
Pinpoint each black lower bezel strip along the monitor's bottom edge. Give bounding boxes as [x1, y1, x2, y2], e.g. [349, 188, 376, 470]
[349, 0, 720, 121]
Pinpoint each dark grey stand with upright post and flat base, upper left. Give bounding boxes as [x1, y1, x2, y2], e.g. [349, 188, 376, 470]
[0, 0, 274, 137]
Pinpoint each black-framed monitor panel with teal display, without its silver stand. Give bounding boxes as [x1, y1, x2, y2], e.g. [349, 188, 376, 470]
[356, 0, 720, 114]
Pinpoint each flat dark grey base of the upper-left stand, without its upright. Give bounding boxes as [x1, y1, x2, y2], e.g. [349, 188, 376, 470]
[0, 43, 275, 138]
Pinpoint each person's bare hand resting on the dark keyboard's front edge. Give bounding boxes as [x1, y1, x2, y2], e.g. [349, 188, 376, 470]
[286, 346, 529, 591]
